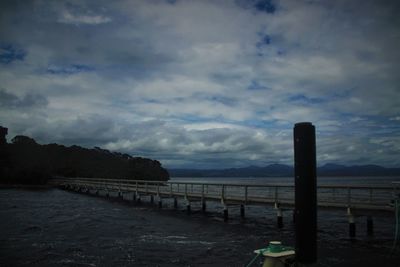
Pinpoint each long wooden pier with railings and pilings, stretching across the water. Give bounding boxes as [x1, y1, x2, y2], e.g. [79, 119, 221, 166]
[50, 177, 400, 238]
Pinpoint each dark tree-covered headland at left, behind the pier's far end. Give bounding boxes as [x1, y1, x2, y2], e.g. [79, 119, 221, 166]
[0, 131, 169, 184]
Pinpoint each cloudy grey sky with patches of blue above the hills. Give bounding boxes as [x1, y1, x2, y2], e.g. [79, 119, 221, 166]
[0, 0, 400, 168]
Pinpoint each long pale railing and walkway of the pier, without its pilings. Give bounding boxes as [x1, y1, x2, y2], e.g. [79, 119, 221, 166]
[52, 178, 399, 211]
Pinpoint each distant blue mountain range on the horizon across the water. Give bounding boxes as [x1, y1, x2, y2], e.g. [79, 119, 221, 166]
[168, 164, 400, 177]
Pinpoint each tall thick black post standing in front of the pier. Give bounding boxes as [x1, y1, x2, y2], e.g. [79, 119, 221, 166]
[293, 122, 317, 264]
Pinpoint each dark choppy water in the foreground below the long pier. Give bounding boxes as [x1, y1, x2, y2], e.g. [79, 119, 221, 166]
[0, 185, 400, 266]
